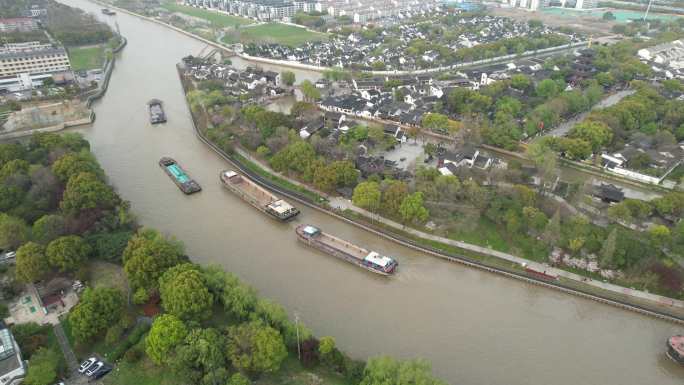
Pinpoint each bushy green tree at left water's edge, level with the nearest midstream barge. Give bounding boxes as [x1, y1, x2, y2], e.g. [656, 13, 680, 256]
[123, 229, 183, 292]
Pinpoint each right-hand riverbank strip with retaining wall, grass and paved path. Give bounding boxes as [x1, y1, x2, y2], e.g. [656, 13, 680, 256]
[178, 64, 684, 324]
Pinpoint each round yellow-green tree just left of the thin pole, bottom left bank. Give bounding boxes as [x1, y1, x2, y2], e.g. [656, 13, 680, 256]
[227, 321, 287, 373]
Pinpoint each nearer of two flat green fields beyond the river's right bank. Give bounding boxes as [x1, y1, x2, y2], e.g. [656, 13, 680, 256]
[223, 23, 328, 47]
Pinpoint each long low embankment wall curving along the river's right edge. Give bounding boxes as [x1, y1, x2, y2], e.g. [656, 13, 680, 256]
[178, 64, 684, 324]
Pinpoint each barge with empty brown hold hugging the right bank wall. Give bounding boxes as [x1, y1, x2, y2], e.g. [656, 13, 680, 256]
[221, 170, 299, 221]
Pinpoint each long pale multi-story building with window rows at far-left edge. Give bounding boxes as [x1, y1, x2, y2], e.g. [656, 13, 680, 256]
[0, 42, 71, 78]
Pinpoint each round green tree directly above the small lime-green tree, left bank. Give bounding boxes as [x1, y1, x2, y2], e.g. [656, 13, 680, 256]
[159, 263, 214, 321]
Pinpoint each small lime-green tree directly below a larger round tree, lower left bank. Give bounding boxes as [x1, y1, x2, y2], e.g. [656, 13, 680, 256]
[145, 314, 188, 365]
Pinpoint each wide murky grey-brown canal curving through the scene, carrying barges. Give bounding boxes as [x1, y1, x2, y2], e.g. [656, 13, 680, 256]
[63, 0, 684, 385]
